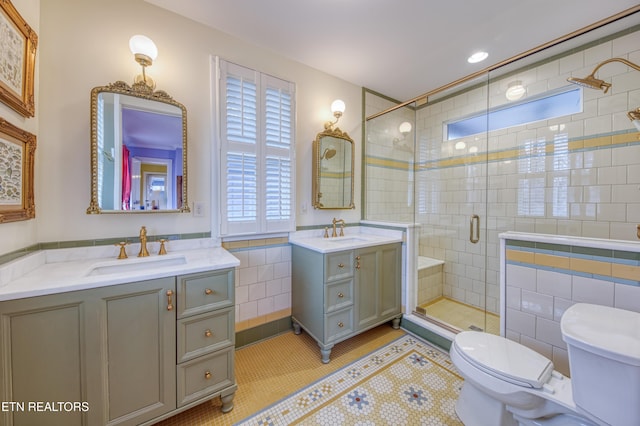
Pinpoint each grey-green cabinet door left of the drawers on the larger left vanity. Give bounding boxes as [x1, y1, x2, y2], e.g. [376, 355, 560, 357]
[92, 277, 176, 425]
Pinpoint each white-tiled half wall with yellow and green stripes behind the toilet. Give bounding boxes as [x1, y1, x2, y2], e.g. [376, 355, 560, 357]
[500, 232, 640, 375]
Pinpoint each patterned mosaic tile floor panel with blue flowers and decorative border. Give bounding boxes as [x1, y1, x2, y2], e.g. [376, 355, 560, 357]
[237, 335, 463, 426]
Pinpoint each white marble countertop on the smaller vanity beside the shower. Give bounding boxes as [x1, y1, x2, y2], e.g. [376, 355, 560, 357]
[289, 226, 404, 253]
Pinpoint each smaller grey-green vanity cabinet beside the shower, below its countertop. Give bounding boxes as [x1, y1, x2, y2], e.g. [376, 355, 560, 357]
[291, 243, 402, 363]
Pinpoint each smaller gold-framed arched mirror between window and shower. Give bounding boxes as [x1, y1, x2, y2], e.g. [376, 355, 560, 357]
[312, 127, 355, 209]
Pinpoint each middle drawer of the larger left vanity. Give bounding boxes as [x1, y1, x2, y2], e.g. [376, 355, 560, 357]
[178, 307, 235, 363]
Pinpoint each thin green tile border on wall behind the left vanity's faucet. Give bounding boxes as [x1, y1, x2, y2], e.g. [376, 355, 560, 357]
[0, 232, 211, 265]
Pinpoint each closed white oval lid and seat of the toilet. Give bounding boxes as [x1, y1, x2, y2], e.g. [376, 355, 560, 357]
[454, 331, 553, 389]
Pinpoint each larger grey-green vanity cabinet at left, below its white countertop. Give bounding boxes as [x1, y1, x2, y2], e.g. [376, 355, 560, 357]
[0, 268, 237, 426]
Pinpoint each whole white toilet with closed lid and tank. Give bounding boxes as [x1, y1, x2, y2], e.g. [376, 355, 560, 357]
[450, 303, 640, 426]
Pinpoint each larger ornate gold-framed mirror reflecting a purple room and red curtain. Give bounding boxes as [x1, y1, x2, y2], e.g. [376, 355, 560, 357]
[87, 81, 190, 214]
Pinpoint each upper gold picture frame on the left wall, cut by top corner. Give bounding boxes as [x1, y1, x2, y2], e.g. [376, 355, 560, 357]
[0, 0, 38, 117]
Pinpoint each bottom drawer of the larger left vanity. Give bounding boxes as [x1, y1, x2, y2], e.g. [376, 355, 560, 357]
[177, 347, 235, 407]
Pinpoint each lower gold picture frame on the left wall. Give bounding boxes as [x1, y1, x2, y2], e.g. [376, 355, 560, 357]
[0, 116, 36, 223]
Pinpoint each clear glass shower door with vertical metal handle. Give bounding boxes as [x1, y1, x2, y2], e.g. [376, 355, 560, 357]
[415, 91, 492, 334]
